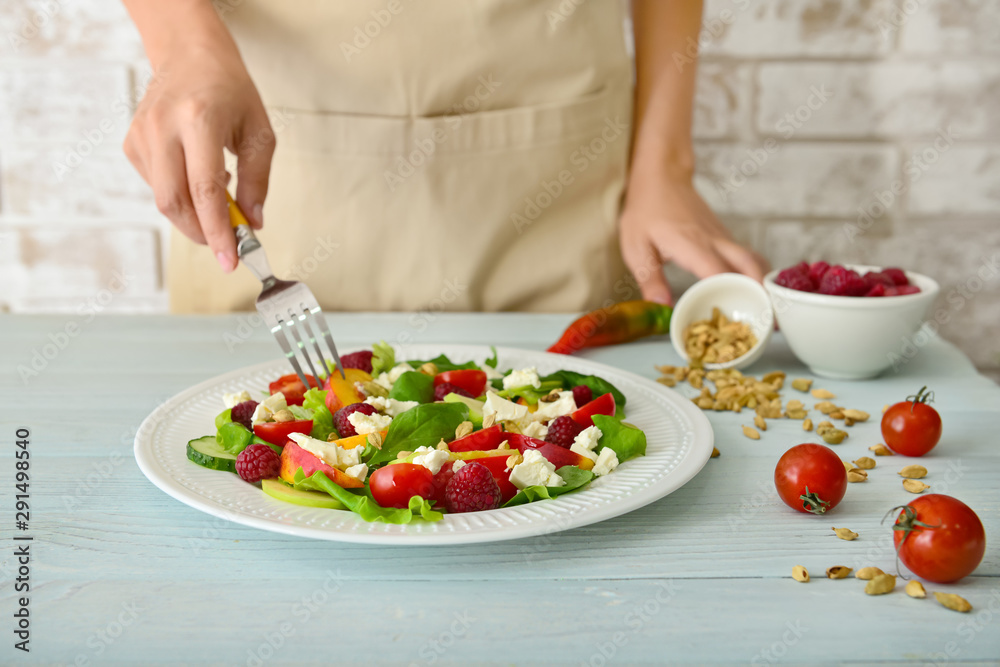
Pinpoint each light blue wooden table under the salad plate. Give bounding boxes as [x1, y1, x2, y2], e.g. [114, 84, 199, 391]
[0, 314, 1000, 666]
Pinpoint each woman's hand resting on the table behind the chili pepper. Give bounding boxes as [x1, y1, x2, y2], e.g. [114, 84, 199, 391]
[621, 168, 767, 303]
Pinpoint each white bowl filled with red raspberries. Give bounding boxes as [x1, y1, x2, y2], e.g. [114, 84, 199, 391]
[764, 261, 939, 379]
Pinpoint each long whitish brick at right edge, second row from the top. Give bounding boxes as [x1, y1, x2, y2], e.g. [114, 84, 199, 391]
[756, 62, 1000, 139]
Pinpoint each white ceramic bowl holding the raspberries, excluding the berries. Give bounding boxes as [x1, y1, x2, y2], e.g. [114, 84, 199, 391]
[764, 264, 940, 380]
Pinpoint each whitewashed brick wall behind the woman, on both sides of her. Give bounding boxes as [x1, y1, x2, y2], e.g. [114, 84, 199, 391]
[0, 0, 1000, 369]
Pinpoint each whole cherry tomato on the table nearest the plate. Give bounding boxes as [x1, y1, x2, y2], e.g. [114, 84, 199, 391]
[774, 443, 847, 514]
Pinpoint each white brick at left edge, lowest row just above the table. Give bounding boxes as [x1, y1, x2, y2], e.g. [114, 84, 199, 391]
[0, 223, 162, 312]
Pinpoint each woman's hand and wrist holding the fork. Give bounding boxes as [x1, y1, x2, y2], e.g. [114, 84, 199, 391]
[124, 0, 275, 272]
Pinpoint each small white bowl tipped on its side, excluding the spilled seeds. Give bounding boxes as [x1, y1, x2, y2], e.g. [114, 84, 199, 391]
[670, 273, 774, 370]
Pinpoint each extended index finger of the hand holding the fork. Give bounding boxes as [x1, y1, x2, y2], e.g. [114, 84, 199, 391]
[184, 123, 236, 273]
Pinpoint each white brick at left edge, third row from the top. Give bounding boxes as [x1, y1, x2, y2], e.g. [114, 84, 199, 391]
[0, 146, 154, 221]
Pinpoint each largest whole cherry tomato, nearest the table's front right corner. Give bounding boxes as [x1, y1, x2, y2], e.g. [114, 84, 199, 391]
[893, 493, 986, 584]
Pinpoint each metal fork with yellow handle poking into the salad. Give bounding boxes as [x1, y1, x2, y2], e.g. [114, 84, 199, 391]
[226, 192, 344, 389]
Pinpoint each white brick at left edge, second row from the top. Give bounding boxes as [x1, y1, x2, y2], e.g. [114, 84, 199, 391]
[0, 63, 132, 143]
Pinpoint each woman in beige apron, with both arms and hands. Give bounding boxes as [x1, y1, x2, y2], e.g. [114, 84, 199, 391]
[125, 0, 764, 312]
